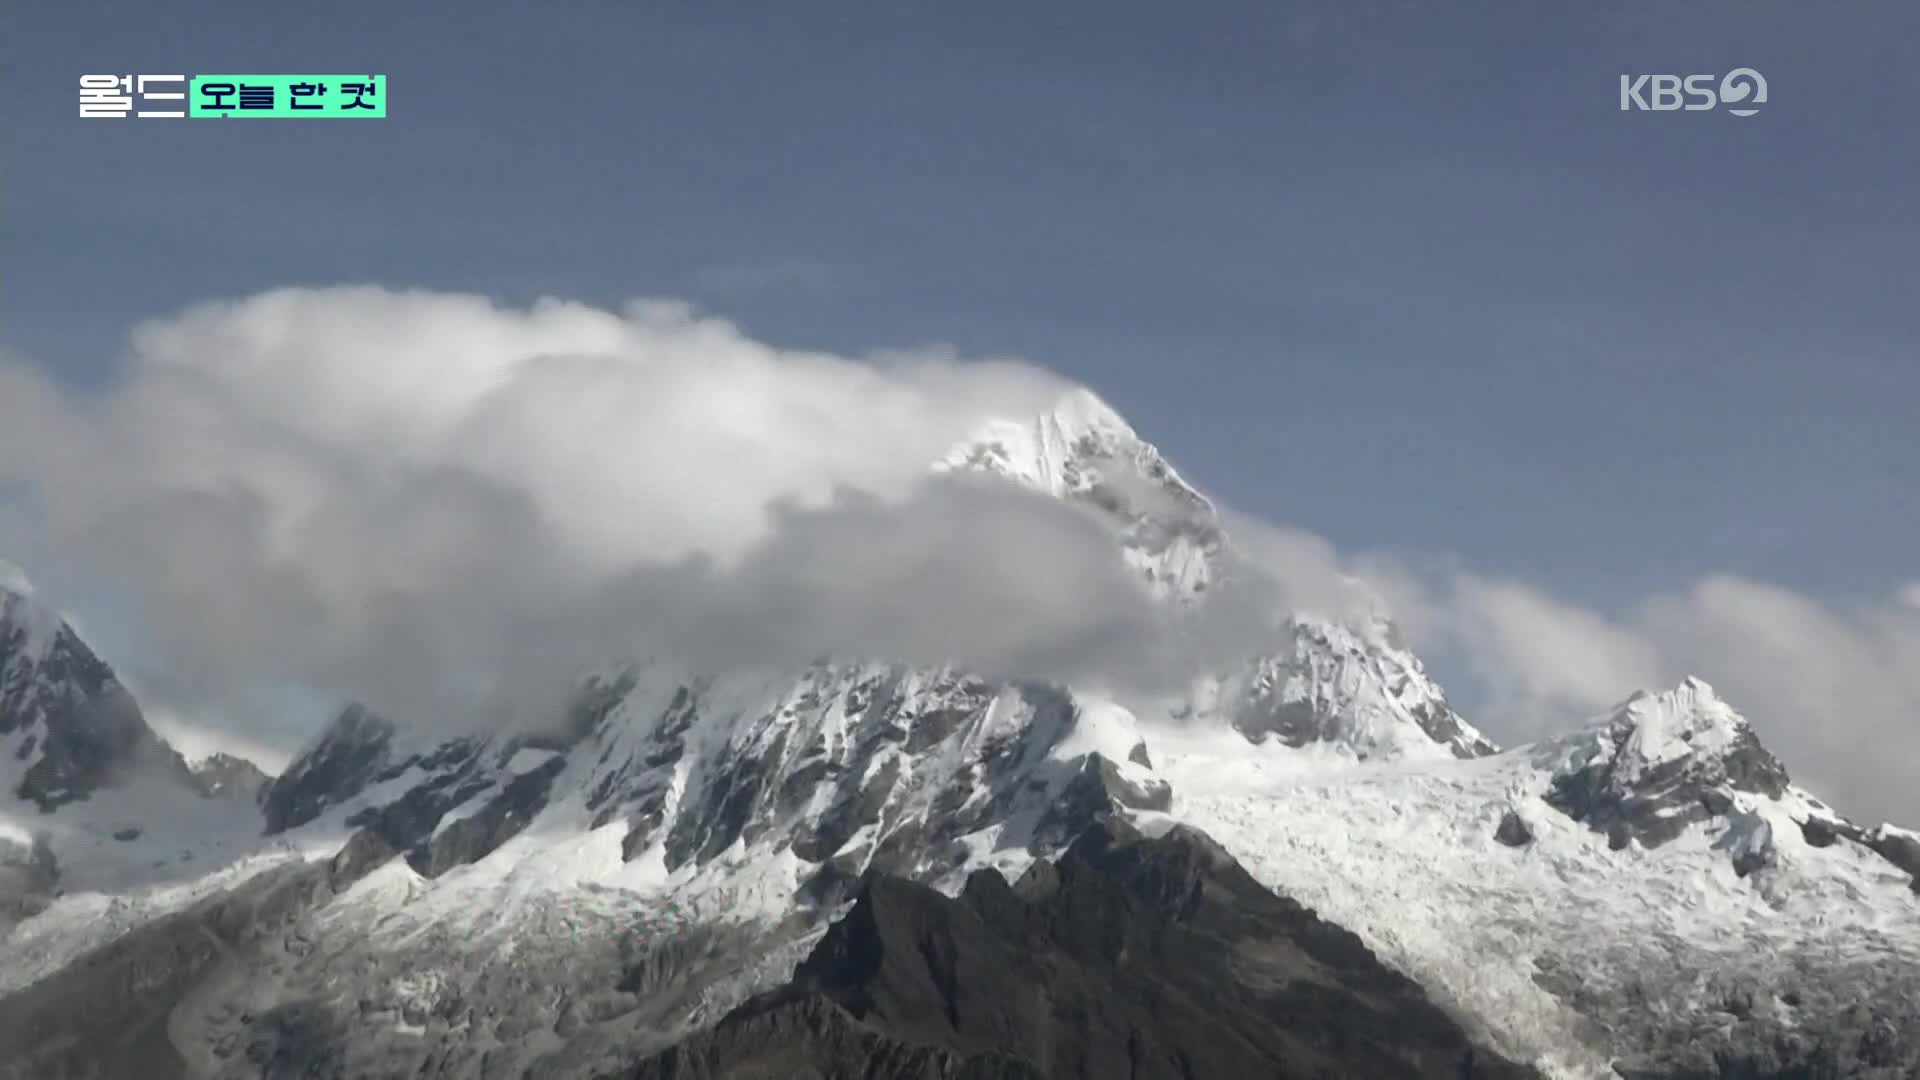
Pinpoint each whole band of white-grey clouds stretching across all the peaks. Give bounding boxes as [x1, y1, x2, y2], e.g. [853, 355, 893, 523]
[0, 288, 1920, 819]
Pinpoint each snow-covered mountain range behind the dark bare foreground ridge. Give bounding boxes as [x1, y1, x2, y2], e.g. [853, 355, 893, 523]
[0, 392, 1920, 1078]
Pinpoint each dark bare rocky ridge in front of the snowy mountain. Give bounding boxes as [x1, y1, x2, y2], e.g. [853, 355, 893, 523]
[626, 824, 1532, 1080]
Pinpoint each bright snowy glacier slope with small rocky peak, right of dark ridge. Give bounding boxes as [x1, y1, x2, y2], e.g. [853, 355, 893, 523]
[1156, 680, 1920, 1076]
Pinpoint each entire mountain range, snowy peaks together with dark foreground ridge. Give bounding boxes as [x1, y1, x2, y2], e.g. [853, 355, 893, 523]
[0, 396, 1920, 1078]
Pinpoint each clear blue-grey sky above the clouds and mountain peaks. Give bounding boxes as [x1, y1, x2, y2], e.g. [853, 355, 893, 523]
[0, 0, 1920, 814]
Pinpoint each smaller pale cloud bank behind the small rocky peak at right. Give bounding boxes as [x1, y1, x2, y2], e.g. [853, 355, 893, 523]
[1436, 575, 1920, 821]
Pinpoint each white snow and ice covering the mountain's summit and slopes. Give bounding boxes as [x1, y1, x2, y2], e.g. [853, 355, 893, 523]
[0, 394, 1920, 1076]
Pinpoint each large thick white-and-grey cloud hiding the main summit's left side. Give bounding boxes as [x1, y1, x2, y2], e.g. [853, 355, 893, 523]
[0, 288, 1259, 740]
